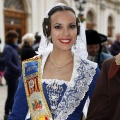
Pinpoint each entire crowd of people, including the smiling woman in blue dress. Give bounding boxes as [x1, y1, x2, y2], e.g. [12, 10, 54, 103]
[0, 3, 120, 120]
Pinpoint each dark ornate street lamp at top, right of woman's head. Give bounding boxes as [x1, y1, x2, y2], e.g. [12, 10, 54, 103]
[74, 0, 87, 22]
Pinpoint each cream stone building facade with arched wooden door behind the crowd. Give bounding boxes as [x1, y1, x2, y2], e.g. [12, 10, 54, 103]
[0, 0, 120, 49]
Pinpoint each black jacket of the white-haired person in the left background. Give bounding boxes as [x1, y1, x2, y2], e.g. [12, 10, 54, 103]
[20, 45, 36, 61]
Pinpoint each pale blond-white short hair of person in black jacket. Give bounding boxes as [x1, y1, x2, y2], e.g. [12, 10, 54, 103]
[21, 33, 35, 46]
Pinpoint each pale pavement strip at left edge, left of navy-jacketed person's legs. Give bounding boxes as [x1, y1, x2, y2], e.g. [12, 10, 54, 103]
[0, 80, 7, 120]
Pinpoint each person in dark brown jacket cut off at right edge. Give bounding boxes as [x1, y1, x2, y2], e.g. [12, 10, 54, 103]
[86, 54, 120, 120]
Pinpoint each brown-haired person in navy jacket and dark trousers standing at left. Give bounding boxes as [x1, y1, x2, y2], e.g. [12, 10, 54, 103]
[3, 30, 21, 120]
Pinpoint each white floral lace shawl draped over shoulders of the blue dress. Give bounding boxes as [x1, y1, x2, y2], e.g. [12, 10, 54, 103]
[42, 52, 97, 120]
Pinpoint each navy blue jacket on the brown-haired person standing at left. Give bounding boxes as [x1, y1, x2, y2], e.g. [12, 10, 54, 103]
[3, 44, 21, 78]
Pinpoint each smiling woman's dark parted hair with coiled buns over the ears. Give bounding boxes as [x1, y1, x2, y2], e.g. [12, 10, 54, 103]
[42, 5, 80, 37]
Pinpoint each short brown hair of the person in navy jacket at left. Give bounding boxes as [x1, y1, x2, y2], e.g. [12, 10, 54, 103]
[5, 30, 19, 44]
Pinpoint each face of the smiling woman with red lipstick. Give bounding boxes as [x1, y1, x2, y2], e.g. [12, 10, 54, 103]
[50, 10, 77, 50]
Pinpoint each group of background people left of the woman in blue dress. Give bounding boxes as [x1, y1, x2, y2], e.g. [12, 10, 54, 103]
[0, 30, 40, 120]
